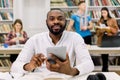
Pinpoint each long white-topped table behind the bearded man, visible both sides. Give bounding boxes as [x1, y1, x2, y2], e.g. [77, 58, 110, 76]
[0, 45, 120, 54]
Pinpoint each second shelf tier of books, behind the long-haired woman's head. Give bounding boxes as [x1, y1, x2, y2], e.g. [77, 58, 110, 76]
[88, 6, 120, 22]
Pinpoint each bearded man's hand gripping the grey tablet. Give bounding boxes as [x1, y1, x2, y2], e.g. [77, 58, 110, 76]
[46, 54, 79, 76]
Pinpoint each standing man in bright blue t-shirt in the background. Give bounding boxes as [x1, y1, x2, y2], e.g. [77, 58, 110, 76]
[67, 1, 93, 45]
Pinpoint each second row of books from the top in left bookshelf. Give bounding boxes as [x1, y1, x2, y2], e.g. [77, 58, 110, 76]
[0, 12, 13, 21]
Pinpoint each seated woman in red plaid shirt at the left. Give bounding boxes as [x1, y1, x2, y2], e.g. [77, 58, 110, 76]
[5, 19, 28, 62]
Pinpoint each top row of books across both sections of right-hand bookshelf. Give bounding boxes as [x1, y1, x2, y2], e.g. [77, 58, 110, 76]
[51, 0, 120, 7]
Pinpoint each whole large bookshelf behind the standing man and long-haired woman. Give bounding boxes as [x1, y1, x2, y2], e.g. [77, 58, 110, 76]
[50, 0, 120, 71]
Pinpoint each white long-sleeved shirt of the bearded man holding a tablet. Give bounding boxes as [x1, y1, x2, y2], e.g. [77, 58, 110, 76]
[11, 31, 94, 75]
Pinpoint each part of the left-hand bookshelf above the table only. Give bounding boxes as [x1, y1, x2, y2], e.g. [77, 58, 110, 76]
[0, 0, 13, 44]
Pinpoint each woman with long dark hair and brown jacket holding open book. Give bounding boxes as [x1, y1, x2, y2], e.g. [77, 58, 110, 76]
[96, 7, 119, 72]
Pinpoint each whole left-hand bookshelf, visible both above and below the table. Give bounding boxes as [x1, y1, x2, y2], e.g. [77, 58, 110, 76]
[0, 0, 13, 72]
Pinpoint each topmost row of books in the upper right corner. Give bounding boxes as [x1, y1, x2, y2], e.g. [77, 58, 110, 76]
[88, 0, 120, 6]
